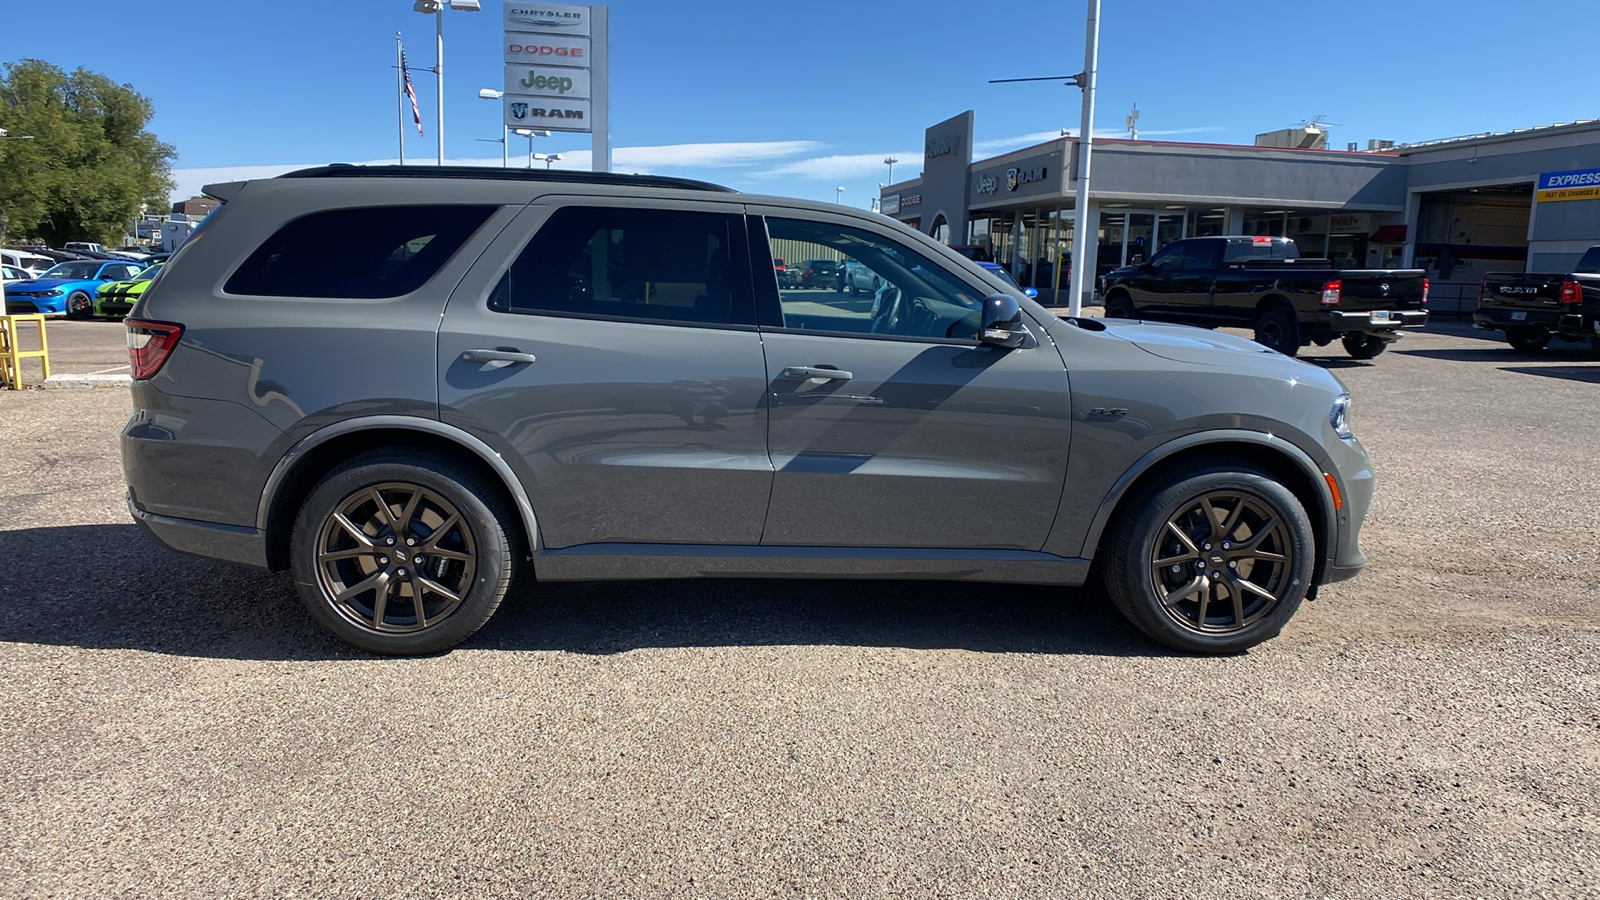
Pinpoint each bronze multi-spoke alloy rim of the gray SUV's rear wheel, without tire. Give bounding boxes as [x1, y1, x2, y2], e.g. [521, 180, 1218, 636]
[317, 482, 477, 634]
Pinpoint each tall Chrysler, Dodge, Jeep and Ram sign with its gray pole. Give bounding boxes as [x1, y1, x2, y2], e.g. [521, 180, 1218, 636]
[501, 0, 611, 171]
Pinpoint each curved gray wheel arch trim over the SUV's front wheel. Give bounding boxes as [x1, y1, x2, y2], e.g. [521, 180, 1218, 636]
[1082, 431, 1338, 589]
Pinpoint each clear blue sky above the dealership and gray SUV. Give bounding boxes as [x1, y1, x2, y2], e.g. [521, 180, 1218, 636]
[0, 0, 1600, 207]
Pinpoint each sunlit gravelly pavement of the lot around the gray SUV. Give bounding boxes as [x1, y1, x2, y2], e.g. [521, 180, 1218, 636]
[0, 323, 1600, 898]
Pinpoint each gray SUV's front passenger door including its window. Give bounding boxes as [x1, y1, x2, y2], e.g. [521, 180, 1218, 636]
[752, 208, 1072, 551]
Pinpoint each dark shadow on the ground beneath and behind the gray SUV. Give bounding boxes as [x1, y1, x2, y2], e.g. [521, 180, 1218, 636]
[0, 525, 1166, 660]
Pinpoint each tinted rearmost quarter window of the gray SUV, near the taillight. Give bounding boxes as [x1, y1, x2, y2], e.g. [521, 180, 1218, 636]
[222, 207, 494, 299]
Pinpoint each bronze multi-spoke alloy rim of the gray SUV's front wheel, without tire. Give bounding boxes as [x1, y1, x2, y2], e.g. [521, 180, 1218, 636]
[1150, 490, 1291, 634]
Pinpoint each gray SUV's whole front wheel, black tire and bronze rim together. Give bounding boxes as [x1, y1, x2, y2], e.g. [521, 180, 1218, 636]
[1101, 458, 1315, 653]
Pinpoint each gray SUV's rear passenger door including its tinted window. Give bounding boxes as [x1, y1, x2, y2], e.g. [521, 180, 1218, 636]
[438, 197, 774, 549]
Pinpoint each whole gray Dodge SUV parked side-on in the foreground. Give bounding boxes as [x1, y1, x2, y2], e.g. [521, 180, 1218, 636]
[122, 167, 1373, 653]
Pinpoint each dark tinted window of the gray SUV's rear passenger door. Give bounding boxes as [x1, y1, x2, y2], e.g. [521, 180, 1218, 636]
[490, 207, 752, 325]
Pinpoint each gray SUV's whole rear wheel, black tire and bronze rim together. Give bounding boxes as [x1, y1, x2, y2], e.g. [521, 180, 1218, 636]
[290, 448, 517, 657]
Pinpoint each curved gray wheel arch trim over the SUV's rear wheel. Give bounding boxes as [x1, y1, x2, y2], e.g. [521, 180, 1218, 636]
[256, 416, 541, 572]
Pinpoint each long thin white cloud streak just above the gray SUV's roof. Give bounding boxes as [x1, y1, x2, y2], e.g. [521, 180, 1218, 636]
[171, 138, 825, 200]
